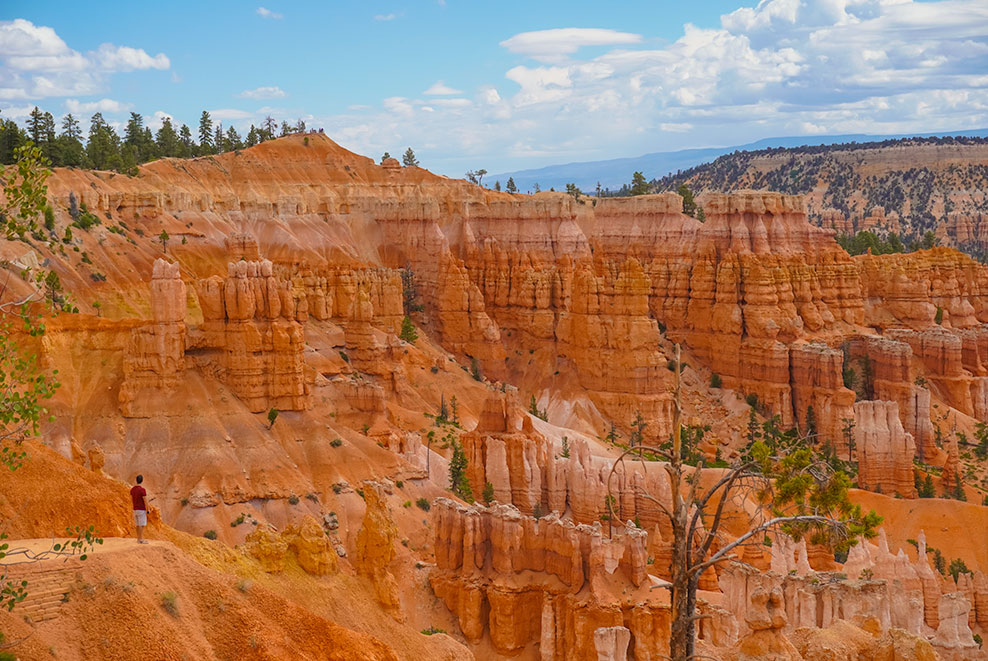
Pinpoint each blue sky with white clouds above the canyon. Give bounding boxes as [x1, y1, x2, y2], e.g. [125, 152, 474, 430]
[0, 0, 988, 177]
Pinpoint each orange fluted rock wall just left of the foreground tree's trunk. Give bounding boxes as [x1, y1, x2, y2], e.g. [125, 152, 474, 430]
[429, 498, 696, 661]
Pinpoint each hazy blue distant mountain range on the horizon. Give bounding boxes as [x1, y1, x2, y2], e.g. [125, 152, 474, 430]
[486, 129, 988, 192]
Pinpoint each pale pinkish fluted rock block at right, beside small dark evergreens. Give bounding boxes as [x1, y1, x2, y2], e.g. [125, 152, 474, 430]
[854, 401, 916, 498]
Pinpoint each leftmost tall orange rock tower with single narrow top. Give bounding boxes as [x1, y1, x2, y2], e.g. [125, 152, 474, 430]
[119, 259, 186, 417]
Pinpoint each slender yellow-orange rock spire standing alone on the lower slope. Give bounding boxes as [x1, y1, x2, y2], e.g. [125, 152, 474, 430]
[353, 480, 405, 622]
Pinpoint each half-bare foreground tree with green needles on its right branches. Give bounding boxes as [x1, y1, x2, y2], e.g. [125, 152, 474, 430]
[606, 344, 881, 661]
